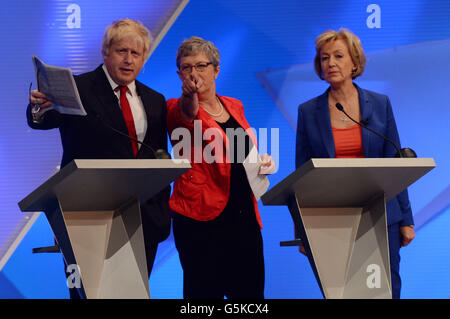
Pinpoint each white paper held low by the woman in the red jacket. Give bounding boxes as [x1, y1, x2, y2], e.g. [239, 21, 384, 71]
[243, 146, 270, 200]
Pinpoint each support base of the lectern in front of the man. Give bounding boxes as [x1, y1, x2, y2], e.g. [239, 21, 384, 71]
[59, 199, 150, 299]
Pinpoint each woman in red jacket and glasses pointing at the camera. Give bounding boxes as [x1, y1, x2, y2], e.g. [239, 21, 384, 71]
[167, 37, 275, 299]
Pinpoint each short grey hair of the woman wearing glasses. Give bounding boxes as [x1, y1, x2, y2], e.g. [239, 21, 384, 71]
[176, 36, 220, 69]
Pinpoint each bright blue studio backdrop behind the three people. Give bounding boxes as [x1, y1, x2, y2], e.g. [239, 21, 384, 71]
[0, 0, 450, 298]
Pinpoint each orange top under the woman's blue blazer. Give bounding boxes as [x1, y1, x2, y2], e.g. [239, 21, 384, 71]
[333, 124, 364, 158]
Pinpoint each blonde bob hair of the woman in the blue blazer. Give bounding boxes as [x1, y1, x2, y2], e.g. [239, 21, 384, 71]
[314, 28, 366, 80]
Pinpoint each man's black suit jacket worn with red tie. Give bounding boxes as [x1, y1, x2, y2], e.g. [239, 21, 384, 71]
[27, 66, 170, 243]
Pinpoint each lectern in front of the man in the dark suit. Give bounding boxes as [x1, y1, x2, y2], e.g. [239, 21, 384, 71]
[19, 159, 191, 298]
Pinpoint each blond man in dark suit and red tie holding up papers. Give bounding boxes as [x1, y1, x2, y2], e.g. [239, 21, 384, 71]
[27, 19, 170, 298]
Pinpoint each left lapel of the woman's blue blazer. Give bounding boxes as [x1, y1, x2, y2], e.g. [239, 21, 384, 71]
[315, 90, 335, 158]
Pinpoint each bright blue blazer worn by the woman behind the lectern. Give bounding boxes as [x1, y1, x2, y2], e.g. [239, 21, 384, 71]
[295, 84, 414, 226]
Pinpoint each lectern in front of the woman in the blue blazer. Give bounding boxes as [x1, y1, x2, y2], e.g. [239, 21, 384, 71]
[262, 158, 435, 298]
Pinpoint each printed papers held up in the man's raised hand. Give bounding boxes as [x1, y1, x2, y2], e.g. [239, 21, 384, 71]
[32, 55, 86, 115]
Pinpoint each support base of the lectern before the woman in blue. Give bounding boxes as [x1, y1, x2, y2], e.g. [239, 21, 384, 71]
[289, 194, 391, 298]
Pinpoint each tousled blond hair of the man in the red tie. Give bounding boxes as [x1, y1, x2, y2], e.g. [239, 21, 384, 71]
[102, 18, 153, 61]
